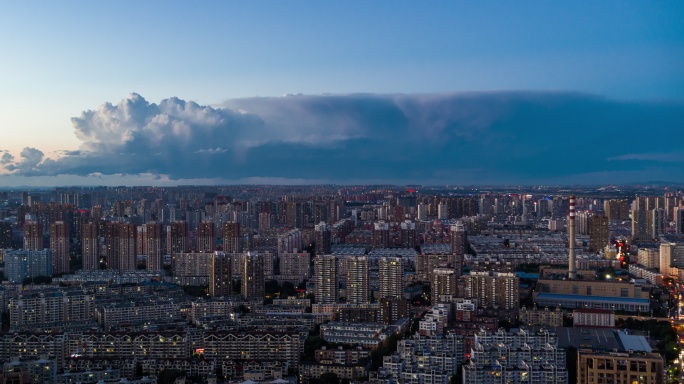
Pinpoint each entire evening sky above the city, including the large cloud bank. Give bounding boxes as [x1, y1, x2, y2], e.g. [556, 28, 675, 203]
[0, 1, 684, 186]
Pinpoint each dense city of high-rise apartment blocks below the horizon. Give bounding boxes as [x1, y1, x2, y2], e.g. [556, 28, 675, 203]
[0, 185, 684, 384]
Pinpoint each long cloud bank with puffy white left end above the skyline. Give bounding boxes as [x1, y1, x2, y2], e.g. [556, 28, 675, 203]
[0, 92, 684, 184]
